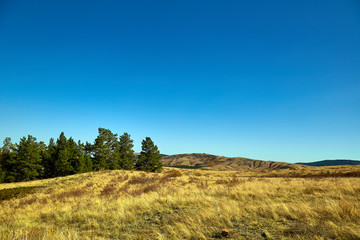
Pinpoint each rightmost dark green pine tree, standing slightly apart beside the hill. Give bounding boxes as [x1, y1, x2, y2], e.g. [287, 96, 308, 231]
[136, 137, 162, 172]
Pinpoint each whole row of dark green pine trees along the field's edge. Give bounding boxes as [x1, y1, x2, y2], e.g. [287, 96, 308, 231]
[0, 128, 162, 183]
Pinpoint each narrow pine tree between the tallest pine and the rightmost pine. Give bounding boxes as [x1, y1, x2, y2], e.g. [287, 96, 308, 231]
[118, 132, 135, 169]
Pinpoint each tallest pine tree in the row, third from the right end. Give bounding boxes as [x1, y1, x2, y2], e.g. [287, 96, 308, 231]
[92, 128, 119, 170]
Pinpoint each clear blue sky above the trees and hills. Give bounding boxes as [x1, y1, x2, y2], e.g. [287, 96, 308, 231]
[0, 0, 360, 162]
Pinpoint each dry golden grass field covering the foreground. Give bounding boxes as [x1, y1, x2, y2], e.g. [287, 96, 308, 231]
[0, 167, 360, 239]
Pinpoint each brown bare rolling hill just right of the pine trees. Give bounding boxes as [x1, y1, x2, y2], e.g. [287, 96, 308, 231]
[161, 153, 304, 171]
